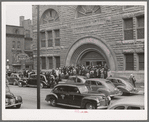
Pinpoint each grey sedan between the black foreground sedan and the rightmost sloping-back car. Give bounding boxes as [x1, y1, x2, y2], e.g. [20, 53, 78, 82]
[85, 78, 122, 97]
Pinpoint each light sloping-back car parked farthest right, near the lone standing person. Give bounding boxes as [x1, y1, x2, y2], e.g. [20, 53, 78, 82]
[107, 77, 138, 94]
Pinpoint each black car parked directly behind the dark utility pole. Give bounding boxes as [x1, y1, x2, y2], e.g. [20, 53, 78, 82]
[18, 74, 50, 88]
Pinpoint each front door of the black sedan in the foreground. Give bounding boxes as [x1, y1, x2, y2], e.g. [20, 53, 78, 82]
[68, 87, 83, 106]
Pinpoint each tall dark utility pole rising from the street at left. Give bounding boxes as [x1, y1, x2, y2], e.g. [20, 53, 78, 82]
[37, 5, 40, 109]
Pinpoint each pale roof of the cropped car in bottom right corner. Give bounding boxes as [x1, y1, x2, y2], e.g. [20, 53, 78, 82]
[109, 95, 144, 108]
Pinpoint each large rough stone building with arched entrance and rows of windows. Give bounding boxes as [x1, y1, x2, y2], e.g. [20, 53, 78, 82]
[32, 5, 145, 82]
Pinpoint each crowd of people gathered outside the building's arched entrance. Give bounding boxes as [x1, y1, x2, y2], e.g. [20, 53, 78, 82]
[8, 63, 136, 87]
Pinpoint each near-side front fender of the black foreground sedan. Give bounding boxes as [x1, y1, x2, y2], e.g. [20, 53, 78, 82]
[81, 97, 97, 108]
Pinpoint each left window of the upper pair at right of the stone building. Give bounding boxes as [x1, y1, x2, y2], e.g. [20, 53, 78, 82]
[124, 18, 133, 40]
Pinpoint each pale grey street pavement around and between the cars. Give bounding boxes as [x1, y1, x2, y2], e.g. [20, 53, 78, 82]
[5, 84, 144, 109]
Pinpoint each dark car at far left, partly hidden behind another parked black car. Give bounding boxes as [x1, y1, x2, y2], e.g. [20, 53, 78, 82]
[7, 73, 21, 85]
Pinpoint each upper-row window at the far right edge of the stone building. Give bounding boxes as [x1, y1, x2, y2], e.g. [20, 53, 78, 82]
[137, 16, 144, 39]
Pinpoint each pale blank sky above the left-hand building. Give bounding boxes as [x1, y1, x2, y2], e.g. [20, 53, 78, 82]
[6, 5, 32, 26]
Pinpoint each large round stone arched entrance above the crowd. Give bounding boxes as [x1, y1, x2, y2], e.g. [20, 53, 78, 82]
[66, 37, 116, 71]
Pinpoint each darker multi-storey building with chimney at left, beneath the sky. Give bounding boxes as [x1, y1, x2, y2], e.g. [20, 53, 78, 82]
[6, 17, 33, 72]
